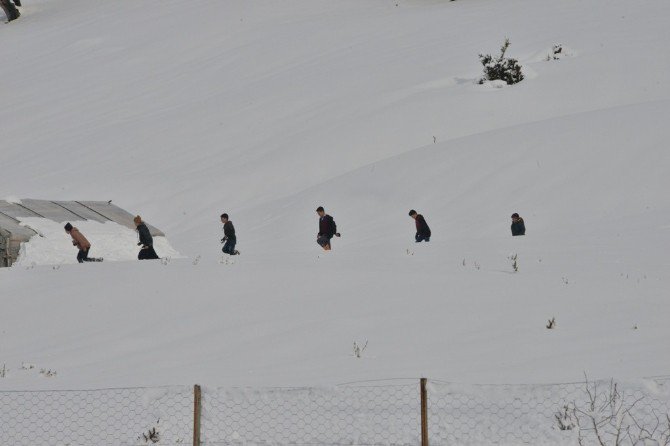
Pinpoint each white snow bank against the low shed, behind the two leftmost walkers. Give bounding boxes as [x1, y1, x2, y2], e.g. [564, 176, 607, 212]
[15, 217, 180, 266]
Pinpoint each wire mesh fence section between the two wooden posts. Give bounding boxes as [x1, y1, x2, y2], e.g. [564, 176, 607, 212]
[201, 382, 421, 445]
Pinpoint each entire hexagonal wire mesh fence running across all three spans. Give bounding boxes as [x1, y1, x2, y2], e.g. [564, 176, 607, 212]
[0, 378, 670, 446]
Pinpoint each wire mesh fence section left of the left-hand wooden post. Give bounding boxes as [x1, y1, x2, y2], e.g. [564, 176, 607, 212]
[0, 387, 193, 446]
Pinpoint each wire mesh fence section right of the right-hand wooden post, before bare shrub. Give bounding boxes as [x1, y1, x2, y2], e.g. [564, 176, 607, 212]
[428, 379, 670, 446]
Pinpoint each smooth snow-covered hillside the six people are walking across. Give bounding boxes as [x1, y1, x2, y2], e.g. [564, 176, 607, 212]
[0, 0, 670, 389]
